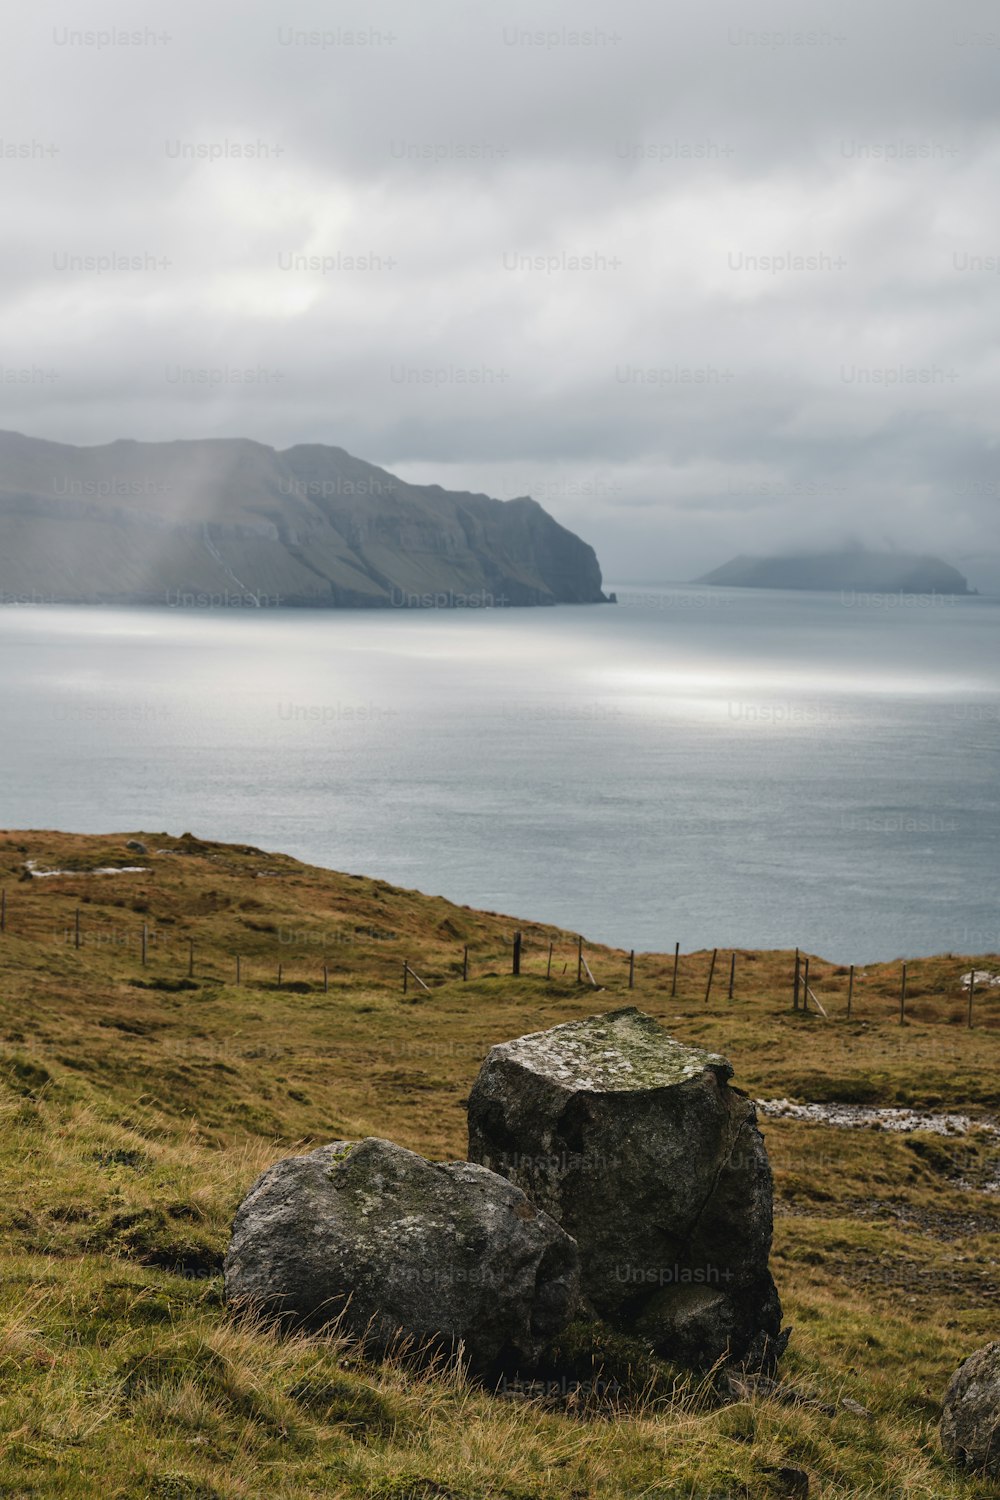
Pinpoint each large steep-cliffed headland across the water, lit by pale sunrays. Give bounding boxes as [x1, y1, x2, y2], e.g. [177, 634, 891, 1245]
[0, 432, 604, 608]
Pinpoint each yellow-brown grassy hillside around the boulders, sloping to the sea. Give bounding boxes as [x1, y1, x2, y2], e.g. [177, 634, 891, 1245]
[0, 833, 1000, 1500]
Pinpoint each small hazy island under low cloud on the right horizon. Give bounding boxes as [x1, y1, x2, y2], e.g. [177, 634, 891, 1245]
[696, 548, 975, 594]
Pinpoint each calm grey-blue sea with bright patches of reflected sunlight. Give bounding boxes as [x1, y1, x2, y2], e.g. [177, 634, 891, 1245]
[0, 584, 1000, 963]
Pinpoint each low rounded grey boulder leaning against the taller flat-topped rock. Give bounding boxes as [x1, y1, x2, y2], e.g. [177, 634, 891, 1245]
[225, 1137, 579, 1371]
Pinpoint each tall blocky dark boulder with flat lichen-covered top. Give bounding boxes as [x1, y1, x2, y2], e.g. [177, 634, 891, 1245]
[469, 1008, 787, 1368]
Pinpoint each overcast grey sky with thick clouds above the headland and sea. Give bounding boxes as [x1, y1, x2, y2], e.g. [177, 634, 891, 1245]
[0, 0, 1000, 588]
